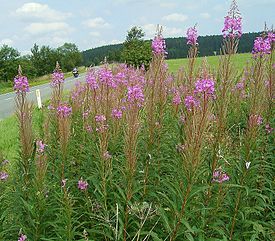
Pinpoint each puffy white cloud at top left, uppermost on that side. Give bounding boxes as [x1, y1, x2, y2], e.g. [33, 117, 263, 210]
[15, 2, 71, 22]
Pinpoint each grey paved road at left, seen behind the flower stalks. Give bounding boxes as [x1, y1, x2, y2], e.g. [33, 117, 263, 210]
[0, 74, 85, 120]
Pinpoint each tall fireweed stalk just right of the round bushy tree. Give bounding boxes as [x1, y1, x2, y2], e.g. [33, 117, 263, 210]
[147, 26, 168, 188]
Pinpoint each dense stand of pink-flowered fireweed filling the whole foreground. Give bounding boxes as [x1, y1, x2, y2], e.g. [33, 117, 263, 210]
[0, 1, 275, 241]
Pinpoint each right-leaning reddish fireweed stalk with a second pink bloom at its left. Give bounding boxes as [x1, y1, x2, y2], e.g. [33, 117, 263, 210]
[170, 66, 215, 241]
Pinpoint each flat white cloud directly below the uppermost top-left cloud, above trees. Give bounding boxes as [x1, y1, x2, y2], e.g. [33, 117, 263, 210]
[25, 22, 73, 36]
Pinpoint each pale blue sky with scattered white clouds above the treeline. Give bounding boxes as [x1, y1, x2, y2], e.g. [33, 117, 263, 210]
[0, 0, 275, 54]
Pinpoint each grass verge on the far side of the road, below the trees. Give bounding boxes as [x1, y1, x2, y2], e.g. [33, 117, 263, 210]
[0, 66, 86, 94]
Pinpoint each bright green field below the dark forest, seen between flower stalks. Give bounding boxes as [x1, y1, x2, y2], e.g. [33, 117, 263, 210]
[166, 53, 251, 73]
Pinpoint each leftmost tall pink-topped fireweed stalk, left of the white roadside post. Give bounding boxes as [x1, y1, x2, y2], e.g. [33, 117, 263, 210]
[14, 65, 33, 183]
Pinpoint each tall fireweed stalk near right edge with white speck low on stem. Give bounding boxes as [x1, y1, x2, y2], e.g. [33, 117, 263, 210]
[230, 33, 270, 240]
